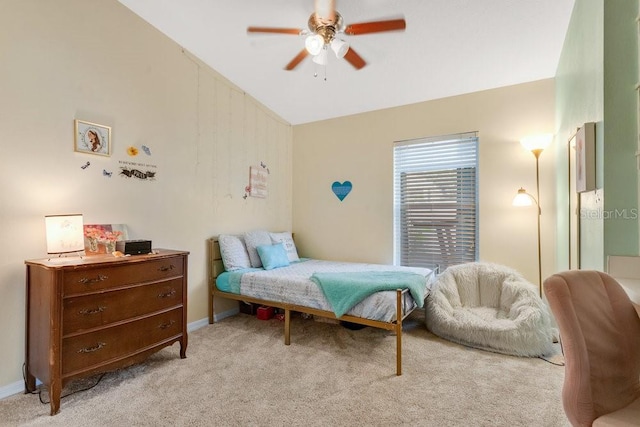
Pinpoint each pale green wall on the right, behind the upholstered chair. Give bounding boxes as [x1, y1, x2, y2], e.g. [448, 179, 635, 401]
[556, 0, 638, 270]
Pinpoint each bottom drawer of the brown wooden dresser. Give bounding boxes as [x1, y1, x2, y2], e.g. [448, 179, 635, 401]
[62, 308, 183, 377]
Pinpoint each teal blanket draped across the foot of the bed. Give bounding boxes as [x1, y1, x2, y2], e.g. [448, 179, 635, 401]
[311, 271, 426, 317]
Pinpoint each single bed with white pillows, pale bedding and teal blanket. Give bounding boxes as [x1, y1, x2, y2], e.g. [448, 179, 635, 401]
[208, 232, 434, 375]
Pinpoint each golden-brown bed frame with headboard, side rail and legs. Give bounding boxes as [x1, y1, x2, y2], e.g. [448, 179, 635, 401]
[207, 237, 422, 375]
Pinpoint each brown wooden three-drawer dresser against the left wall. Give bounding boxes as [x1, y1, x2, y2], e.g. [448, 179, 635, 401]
[25, 249, 189, 415]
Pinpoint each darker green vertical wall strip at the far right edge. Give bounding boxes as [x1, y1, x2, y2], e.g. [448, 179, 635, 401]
[601, 0, 638, 257]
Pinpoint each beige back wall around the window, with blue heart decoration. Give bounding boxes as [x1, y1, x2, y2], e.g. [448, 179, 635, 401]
[293, 80, 555, 283]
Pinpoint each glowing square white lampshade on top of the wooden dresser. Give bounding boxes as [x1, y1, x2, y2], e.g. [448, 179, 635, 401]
[44, 214, 84, 254]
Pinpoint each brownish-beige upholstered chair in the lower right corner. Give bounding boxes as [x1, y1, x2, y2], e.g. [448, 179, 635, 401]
[544, 270, 640, 426]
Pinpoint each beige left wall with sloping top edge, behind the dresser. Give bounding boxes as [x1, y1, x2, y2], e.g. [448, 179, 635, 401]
[0, 0, 292, 395]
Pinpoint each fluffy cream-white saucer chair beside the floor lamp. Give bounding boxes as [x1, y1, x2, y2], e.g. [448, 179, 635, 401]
[426, 262, 553, 357]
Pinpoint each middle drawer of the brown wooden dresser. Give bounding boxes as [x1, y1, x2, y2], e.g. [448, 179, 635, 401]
[62, 278, 182, 336]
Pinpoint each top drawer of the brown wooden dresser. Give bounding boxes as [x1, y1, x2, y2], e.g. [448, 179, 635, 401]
[63, 257, 183, 296]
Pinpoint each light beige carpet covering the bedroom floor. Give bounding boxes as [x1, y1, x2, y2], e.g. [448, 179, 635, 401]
[0, 314, 569, 427]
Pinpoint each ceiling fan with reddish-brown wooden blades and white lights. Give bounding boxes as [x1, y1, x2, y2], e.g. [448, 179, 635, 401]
[247, 0, 407, 71]
